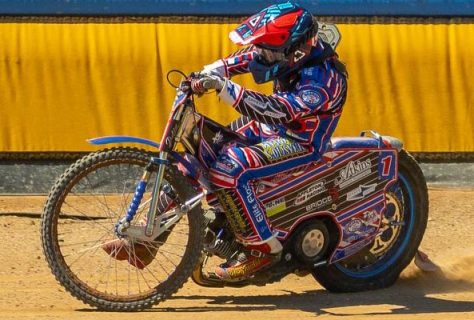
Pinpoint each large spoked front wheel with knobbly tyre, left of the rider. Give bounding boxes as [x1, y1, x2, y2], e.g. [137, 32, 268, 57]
[41, 148, 204, 311]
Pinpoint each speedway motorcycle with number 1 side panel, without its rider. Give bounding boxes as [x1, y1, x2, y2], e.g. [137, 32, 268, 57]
[41, 25, 428, 311]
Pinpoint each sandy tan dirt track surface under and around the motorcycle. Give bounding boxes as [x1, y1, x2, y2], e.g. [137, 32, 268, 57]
[0, 188, 474, 320]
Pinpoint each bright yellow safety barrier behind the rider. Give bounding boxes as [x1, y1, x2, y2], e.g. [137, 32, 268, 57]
[0, 23, 474, 152]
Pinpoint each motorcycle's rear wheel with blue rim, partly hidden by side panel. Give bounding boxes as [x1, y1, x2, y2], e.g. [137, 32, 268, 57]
[312, 150, 428, 292]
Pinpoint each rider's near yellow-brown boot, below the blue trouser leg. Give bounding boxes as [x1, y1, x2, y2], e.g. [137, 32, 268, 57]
[214, 236, 283, 281]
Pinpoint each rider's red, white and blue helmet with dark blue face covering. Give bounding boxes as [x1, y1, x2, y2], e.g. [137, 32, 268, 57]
[229, 1, 318, 83]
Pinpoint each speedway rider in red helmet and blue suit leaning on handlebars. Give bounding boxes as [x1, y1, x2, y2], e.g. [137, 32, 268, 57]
[192, 2, 347, 281]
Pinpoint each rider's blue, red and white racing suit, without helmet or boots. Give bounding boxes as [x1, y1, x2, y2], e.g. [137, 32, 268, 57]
[205, 40, 347, 245]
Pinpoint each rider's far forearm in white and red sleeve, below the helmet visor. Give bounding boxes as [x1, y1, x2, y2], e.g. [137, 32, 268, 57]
[203, 46, 256, 79]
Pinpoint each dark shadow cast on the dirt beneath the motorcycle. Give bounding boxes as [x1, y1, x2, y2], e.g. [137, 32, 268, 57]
[149, 264, 474, 316]
